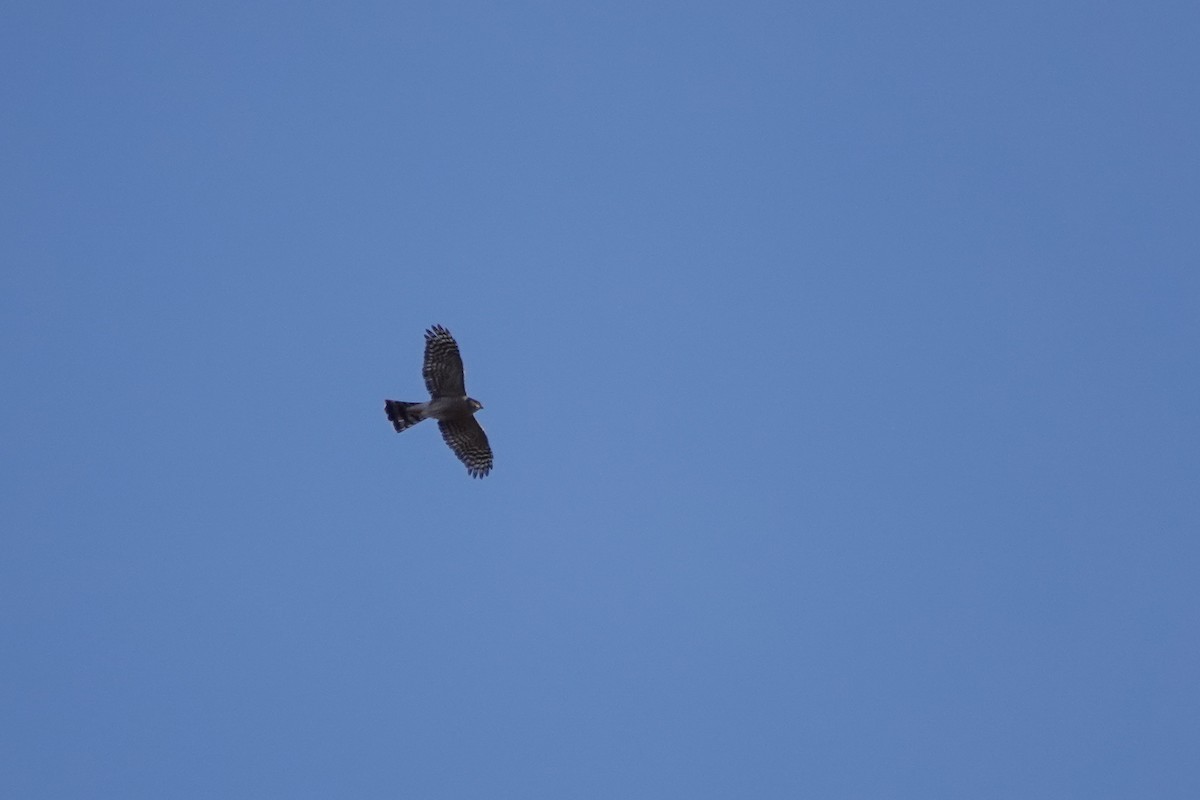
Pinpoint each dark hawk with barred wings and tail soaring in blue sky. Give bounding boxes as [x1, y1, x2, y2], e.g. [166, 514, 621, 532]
[383, 325, 492, 477]
